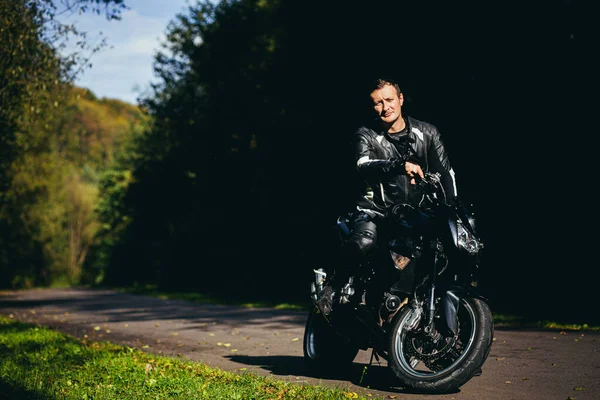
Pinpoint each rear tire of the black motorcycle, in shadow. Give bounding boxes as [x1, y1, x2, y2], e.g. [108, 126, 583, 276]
[303, 307, 358, 373]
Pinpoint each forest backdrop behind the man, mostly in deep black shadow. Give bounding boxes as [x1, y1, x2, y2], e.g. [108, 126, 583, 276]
[0, 0, 600, 323]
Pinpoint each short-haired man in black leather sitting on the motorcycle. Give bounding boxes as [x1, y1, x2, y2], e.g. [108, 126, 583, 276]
[319, 79, 457, 314]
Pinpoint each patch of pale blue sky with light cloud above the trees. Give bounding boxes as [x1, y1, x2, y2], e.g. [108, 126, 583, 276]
[60, 0, 195, 104]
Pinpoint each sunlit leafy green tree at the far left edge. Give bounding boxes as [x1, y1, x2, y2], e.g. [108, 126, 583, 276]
[0, 0, 141, 287]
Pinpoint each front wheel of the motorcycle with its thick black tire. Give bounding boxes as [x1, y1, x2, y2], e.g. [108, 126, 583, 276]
[388, 298, 494, 393]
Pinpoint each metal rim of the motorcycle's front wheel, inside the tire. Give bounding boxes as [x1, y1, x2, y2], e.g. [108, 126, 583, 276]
[394, 300, 477, 379]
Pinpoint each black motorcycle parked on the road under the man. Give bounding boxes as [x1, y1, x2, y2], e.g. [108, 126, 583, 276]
[303, 173, 494, 393]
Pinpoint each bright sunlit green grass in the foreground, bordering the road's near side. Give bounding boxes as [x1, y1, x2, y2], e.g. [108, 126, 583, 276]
[0, 316, 372, 400]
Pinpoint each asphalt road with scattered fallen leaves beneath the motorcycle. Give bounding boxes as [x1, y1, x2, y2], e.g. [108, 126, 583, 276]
[0, 289, 600, 400]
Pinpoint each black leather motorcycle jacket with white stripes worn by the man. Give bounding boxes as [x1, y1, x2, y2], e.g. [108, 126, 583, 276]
[355, 117, 458, 216]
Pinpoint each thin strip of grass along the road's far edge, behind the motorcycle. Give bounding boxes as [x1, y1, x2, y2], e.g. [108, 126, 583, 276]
[117, 285, 600, 331]
